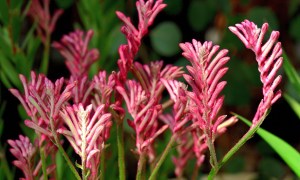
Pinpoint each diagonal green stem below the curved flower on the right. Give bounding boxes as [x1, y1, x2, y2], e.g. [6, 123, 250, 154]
[208, 114, 266, 180]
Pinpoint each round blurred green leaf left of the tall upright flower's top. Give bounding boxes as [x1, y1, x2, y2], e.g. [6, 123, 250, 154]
[150, 22, 181, 56]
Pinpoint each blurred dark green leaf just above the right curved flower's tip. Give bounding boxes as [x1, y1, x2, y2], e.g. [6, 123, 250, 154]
[247, 7, 278, 29]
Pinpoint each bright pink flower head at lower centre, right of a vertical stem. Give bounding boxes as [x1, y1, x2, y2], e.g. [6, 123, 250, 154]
[116, 80, 168, 157]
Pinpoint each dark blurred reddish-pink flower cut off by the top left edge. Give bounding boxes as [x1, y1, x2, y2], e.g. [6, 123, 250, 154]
[28, 0, 63, 43]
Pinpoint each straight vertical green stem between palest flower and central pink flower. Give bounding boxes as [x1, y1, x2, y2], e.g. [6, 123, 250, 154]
[116, 121, 126, 180]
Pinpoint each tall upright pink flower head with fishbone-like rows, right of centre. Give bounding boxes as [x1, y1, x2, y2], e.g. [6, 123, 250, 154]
[180, 40, 229, 138]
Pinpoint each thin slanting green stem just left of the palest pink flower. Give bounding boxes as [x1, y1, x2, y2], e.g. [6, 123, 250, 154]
[50, 118, 81, 180]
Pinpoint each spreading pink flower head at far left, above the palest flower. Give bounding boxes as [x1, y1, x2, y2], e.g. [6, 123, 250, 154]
[10, 72, 75, 137]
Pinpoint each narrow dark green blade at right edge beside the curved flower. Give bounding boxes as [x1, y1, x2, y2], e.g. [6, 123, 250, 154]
[282, 52, 300, 93]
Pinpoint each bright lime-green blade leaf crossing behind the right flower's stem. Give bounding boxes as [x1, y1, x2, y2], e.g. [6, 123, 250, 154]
[238, 116, 300, 178]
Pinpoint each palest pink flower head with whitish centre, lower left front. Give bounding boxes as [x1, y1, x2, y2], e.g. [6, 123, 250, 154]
[57, 104, 112, 179]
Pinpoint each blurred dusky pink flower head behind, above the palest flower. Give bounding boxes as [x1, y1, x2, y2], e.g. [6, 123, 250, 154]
[53, 30, 99, 79]
